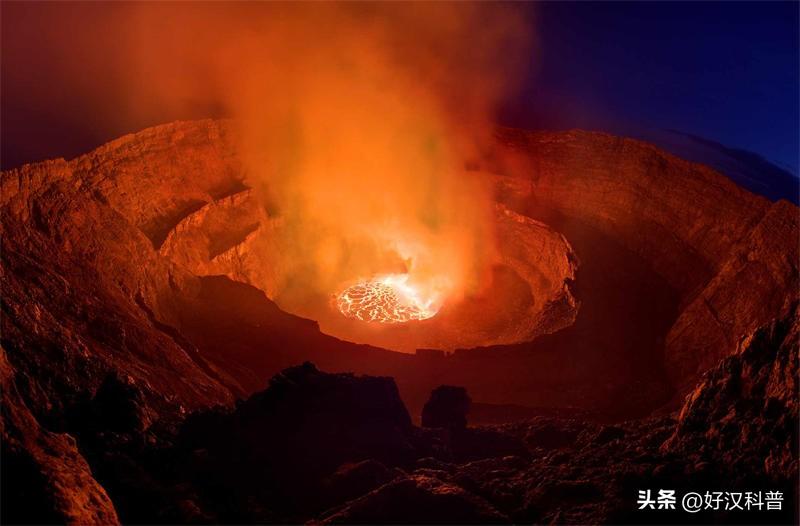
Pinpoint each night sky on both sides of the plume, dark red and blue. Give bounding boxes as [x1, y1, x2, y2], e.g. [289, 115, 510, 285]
[0, 2, 800, 184]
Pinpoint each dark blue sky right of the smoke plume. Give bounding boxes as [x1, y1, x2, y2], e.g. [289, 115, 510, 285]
[504, 2, 800, 174]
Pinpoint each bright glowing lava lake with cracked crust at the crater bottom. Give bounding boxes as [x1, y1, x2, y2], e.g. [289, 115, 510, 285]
[336, 274, 438, 323]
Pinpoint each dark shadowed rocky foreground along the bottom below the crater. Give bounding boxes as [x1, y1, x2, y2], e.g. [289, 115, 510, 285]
[4, 342, 800, 524]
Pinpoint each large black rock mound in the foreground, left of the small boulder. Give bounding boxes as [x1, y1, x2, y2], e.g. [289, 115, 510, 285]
[171, 363, 417, 522]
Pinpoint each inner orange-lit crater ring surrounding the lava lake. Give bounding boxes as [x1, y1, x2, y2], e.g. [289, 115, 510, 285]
[160, 190, 579, 352]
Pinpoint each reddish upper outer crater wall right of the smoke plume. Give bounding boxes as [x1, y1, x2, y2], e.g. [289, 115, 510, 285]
[493, 130, 800, 390]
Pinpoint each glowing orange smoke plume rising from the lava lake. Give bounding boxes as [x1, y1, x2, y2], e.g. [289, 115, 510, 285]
[114, 4, 529, 312]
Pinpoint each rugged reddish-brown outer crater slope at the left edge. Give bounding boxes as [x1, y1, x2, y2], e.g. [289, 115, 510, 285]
[0, 126, 242, 415]
